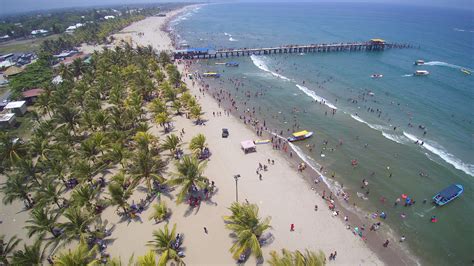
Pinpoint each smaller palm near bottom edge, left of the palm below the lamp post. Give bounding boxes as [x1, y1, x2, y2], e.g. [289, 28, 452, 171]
[148, 224, 183, 266]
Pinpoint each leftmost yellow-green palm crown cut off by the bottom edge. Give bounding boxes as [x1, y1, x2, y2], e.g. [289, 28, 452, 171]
[54, 238, 100, 266]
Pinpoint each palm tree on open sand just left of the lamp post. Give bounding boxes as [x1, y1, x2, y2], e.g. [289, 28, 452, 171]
[166, 155, 208, 204]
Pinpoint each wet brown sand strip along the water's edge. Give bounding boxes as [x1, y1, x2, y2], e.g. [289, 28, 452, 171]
[166, 5, 420, 265]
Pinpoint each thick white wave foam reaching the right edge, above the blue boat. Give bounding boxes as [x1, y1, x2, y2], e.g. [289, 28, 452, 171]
[403, 132, 474, 176]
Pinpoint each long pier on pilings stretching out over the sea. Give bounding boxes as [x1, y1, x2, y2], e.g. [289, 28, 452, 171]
[174, 39, 412, 59]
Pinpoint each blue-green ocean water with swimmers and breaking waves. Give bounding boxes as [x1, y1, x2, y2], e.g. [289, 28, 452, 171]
[170, 3, 474, 265]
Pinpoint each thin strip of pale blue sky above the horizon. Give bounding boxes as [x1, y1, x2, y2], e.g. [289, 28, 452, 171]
[0, 0, 474, 15]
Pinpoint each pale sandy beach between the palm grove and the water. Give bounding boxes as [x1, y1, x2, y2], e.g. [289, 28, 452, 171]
[0, 7, 414, 265]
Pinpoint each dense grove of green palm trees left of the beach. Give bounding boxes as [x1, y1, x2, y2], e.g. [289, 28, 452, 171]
[0, 45, 201, 265]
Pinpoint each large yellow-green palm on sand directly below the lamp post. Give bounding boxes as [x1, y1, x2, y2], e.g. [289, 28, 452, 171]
[224, 202, 271, 260]
